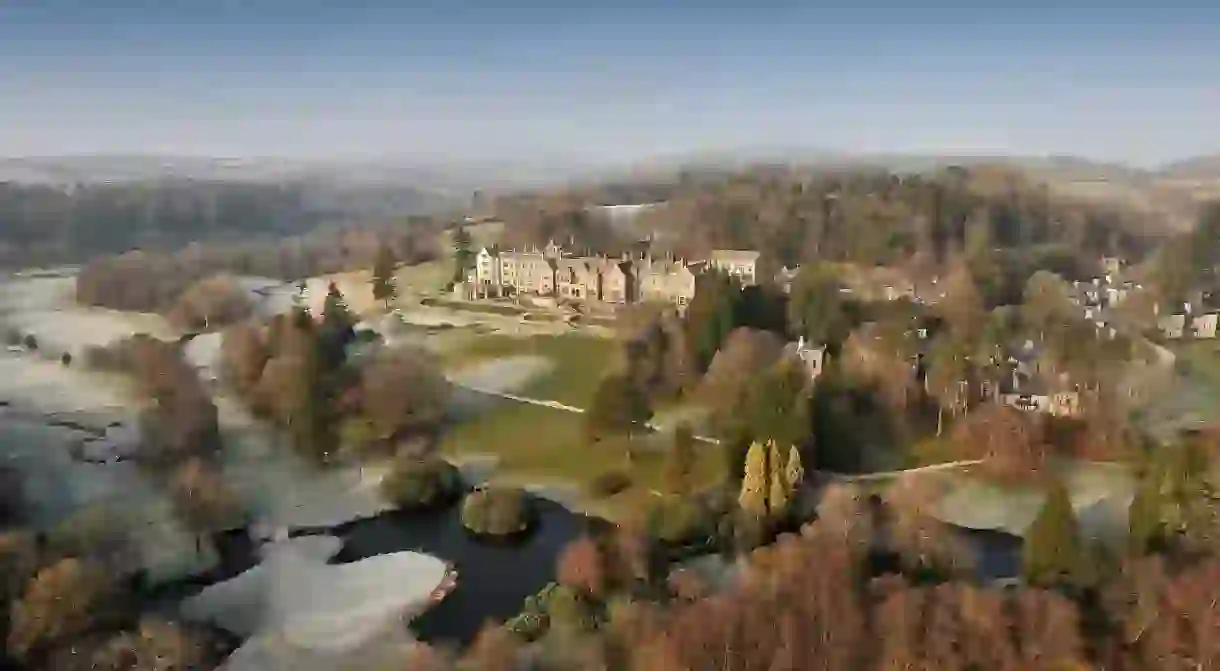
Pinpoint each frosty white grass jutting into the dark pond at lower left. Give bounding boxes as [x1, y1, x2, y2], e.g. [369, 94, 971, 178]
[182, 537, 445, 671]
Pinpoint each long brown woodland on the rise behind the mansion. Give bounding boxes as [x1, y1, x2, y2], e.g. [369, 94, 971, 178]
[497, 166, 1161, 277]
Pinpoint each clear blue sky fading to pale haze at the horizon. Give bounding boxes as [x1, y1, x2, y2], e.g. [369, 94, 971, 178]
[0, 0, 1220, 166]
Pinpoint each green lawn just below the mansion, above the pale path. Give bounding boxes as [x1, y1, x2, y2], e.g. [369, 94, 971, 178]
[444, 333, 619, 407]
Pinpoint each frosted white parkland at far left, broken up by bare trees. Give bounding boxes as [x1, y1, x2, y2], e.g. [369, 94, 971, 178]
[0, 277, 424, 578]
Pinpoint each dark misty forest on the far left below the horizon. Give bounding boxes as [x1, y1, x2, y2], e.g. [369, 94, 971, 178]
[0, 178, 456, 267]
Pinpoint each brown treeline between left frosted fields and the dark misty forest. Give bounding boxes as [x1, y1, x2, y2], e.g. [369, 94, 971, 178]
[76, 222, 438, 328]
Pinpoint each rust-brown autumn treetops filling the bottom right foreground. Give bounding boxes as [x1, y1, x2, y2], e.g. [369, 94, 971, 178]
[411, 461, 1220, 671]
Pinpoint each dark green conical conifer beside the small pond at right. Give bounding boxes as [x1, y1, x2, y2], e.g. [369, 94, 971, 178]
[1021, 482, 1087, 587]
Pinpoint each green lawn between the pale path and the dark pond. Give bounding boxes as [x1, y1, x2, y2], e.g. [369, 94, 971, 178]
[442, 404, 723, 520]
